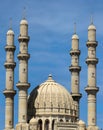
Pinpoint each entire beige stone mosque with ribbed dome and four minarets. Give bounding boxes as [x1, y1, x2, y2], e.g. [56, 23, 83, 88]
[3, 19, 99, 130]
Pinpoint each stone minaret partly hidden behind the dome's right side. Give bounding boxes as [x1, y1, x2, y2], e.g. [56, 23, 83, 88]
[69, 23, 82, 119]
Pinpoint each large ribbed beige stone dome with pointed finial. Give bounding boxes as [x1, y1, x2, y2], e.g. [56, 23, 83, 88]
[28, 75, 77, 121]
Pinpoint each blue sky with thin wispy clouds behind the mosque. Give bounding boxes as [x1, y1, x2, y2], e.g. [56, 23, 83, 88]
[0, 0, 103, 130]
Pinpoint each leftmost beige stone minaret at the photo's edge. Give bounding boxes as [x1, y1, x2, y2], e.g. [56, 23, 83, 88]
[3, 26, 16, 130]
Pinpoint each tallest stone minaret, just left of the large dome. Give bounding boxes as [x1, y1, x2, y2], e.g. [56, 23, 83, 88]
[16, 19, 30, 124]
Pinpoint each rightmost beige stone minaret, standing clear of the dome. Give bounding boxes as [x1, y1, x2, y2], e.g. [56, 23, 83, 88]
[85, 21, 99, 130]
